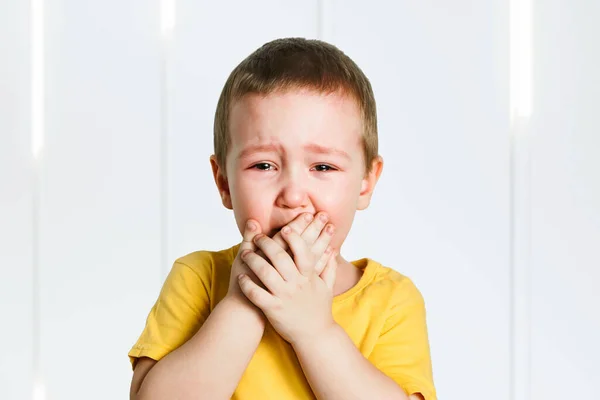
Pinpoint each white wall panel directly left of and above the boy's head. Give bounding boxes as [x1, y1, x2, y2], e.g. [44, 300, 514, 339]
[164, 0, 318, 273]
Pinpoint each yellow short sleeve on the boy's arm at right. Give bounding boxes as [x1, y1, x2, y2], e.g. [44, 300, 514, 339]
[369, 278, 437, 400]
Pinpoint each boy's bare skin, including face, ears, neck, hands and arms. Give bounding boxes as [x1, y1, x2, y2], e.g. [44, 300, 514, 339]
[131, 91, 422, 400]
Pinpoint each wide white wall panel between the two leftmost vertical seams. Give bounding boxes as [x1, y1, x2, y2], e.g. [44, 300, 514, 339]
[40, 0, 161, 400]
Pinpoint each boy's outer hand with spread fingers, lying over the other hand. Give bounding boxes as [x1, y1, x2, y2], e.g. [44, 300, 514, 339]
[239, 220, 337, 345]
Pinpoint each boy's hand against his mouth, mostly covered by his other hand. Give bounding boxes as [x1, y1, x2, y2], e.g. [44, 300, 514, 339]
[227, 213, 329, 301]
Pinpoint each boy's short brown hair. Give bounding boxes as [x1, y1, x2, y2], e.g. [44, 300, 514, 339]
[214, 38, 378, 173]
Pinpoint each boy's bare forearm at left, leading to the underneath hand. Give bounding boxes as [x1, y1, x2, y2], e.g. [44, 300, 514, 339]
[137, 298, 265, 400]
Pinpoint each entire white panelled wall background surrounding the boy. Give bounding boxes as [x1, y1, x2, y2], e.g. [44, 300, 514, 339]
[0, 0, 600, 400]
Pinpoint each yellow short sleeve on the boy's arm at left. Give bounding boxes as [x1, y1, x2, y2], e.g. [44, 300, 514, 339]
[129, 257, 213, 368]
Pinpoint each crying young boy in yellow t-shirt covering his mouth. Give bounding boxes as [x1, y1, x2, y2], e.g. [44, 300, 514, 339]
[129, 39, 436, 400]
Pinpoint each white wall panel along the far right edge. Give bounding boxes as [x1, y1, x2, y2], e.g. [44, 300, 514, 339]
[531, 0, 600, 400]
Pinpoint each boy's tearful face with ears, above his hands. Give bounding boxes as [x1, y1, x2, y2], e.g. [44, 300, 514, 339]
[211, 91, 383, 253]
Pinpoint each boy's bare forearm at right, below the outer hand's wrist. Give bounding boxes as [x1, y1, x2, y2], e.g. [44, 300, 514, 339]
[293, 324, 408, 400]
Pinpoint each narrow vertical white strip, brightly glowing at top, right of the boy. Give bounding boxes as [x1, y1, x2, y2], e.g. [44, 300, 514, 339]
[508, 0, 533, 400]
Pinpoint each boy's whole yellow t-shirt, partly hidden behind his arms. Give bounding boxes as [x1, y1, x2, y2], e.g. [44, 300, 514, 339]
[129, 245, 436, 400]
